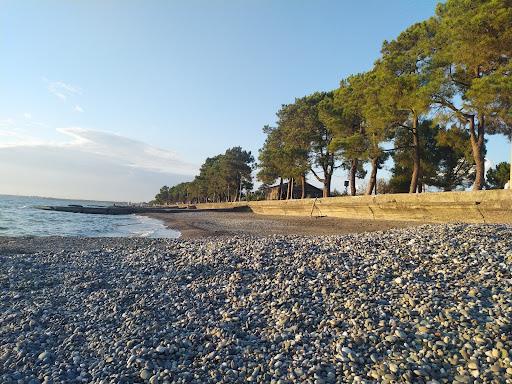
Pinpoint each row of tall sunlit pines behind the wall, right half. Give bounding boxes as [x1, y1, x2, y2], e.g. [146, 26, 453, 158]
[258, 0, 512, 196]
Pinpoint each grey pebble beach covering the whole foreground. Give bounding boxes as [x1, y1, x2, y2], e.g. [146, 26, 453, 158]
[0, 224, 512, 384]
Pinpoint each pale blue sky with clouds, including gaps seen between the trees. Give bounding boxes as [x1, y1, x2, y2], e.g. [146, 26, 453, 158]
[0, 0, 510, 201]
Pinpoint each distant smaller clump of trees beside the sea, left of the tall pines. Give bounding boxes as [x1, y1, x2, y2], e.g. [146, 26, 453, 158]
[154, 147, 254, 204]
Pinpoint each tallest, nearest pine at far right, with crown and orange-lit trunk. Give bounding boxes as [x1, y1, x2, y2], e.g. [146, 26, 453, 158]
[429, 0, 512, 189]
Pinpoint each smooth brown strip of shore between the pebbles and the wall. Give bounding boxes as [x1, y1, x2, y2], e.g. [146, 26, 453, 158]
[141, 211, 421, 239]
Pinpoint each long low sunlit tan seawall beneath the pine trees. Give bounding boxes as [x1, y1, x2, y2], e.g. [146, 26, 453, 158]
[193, 190, 512, 223]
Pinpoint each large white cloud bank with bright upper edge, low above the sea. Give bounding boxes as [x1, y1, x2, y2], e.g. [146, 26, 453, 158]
[0, 127, 197, 201]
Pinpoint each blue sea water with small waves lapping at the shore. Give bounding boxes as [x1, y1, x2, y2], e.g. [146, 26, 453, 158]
[0, 195, 180, 238]
